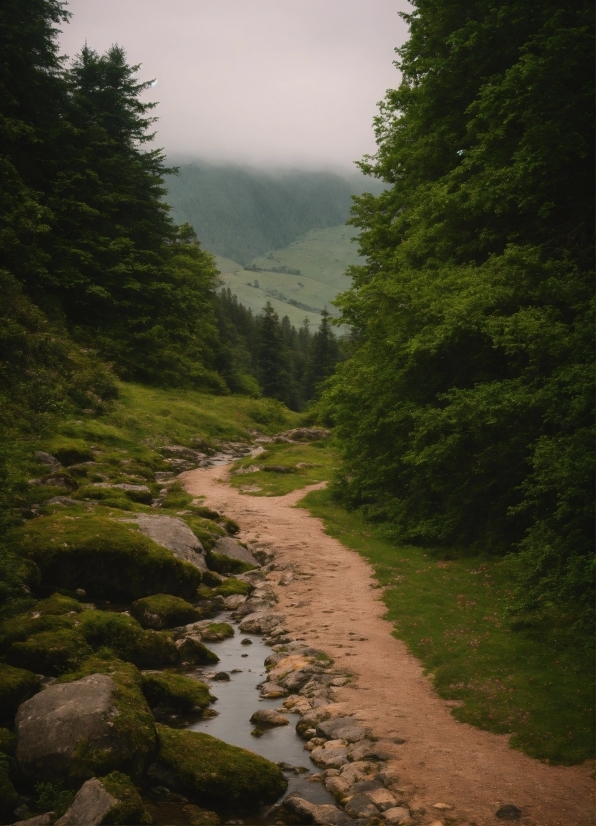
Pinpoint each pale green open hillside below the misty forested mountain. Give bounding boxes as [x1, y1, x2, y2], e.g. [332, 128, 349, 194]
[216, 225, 363, 332]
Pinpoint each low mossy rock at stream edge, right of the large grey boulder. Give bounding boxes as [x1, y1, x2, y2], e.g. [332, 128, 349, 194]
[148, 725, 287, 809]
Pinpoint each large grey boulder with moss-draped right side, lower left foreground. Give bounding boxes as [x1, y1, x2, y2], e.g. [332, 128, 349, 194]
[15, 674, 155, 782]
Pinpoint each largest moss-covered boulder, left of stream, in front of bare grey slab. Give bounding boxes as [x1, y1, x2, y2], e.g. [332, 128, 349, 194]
[11, 513, 201, 602]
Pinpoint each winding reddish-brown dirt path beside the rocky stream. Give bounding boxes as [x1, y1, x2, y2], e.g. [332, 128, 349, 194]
[182, 467, 595, 826]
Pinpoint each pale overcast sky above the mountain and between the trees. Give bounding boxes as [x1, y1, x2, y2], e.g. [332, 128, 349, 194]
[61, 0, 409, 167]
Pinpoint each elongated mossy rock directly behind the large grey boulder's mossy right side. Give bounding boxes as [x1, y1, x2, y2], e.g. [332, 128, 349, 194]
[79, 611, 178, 668]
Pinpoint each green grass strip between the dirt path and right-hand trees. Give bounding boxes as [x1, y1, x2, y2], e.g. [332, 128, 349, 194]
[299, 491, 594, 765]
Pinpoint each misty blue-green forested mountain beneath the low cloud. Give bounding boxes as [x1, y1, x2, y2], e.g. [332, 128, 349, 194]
[166, 161, 382, 264]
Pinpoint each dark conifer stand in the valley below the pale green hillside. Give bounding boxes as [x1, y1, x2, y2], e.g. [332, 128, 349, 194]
[216, 288, 345, 410]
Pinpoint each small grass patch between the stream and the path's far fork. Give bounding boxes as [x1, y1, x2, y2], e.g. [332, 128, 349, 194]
[230, 439, 337, 496]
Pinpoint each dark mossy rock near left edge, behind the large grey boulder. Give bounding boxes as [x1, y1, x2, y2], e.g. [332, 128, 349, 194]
[6, 628, 93, 677]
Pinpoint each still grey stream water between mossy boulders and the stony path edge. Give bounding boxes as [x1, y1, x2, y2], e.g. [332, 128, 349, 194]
[189, 614, 334, 803]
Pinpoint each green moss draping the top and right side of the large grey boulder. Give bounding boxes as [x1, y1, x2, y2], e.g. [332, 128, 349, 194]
[59, 656, 156, 782]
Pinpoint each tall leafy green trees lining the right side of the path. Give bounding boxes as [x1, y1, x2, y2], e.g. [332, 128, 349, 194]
[325, 0, 594, 622]
